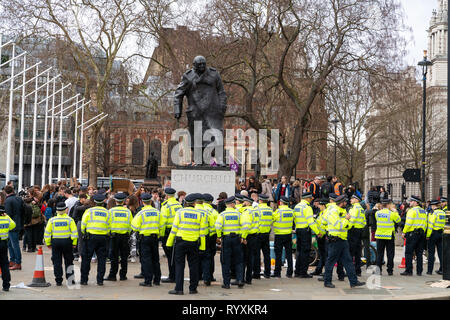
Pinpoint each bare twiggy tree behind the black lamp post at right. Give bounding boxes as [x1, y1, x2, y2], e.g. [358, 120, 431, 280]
[370, 68, 447, 192]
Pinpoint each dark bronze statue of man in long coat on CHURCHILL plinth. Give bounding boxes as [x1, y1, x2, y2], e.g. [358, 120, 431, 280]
[174, 56, 227, 163]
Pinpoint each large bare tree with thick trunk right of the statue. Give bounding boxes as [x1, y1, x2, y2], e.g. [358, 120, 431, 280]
[193, 0, 403, 176]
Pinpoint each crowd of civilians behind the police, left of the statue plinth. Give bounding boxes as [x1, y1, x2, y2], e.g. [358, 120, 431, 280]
[0, 180, 186, 270]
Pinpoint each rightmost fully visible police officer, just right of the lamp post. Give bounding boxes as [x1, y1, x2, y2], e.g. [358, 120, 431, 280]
[427, 200, 445, 274]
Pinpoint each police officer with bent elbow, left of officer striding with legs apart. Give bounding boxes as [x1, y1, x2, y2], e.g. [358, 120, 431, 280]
[294, 192, 323, 278]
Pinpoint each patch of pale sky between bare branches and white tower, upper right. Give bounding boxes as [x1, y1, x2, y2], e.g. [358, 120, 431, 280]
[401, 0, 438, 65]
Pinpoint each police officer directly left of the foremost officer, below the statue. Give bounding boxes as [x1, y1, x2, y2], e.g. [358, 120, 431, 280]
[161, 188, 182, 283]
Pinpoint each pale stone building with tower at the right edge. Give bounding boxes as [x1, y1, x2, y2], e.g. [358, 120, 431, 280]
[364, 0, 448, 201]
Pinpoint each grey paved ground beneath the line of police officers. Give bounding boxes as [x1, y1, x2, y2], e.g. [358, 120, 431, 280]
[0, 242, 450, 300]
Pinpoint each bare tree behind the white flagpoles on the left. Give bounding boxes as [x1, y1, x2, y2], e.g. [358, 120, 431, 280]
[1, 0, 178, 186]
